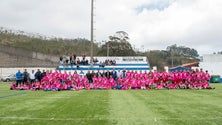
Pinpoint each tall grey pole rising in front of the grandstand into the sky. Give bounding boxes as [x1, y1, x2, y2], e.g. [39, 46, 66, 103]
[90, 0, 94, 67]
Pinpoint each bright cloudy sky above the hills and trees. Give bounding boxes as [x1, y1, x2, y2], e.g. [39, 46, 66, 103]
[0, 0, 222, 55]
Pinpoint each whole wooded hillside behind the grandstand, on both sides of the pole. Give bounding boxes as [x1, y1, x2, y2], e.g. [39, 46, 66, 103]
[0, 28, 198, 70]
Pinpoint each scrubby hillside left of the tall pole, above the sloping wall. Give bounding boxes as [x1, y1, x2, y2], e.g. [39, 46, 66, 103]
[0, 30, 97, 56]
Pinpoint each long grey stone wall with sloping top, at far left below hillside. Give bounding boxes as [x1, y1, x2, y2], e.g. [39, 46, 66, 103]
[0, 45, 59, 67]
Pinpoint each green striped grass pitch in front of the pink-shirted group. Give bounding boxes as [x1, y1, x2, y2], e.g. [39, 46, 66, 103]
[0, 83, 222, 125]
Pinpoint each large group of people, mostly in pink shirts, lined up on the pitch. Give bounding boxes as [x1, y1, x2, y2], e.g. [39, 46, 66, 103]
[10, 69, 212, 91]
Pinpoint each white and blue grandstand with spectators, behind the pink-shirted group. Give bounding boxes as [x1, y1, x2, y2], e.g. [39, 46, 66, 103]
[58, 56, 150, 71]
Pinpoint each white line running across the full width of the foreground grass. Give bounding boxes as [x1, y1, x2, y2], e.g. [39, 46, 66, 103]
[0, 116, 222, 122]
